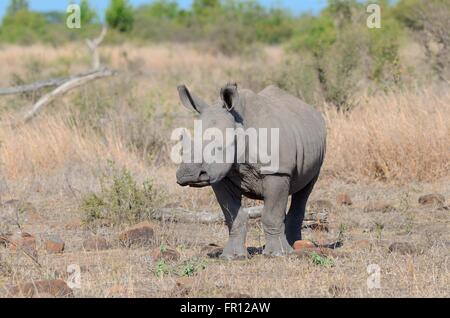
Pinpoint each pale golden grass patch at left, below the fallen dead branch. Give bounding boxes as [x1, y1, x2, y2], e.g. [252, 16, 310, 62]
[0, 115, 142, 180]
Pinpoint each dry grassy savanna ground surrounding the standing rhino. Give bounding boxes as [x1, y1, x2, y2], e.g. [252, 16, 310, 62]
[0, 44, 450, 297]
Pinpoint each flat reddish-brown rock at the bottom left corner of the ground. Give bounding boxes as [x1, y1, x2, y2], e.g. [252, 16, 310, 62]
[8, 279, 73, 298]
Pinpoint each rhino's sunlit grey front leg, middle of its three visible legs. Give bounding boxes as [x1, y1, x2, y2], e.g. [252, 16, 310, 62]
[261, 175, 293, 256]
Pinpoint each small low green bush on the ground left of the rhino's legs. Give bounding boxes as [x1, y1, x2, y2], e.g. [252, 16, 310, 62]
[81, 164, 158, 226]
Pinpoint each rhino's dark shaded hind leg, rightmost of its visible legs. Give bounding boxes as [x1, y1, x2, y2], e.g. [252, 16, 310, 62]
[285, 176, 318, 246]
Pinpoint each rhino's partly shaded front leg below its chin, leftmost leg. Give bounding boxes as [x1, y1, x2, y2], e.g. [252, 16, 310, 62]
[213, 179, 249, 260]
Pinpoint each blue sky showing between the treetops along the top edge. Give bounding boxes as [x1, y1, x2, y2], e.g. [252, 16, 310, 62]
[0, 0, 327, 17]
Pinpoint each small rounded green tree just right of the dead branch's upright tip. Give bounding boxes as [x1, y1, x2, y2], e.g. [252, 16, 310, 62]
[106, 0, 134, 32]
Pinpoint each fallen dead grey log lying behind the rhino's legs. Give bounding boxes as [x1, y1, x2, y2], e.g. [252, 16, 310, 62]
[153, 206, 328, 230]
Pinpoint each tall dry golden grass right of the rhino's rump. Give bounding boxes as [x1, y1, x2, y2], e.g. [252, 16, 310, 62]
[326, 87, 450, 181]
